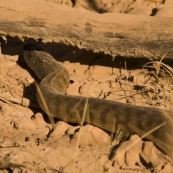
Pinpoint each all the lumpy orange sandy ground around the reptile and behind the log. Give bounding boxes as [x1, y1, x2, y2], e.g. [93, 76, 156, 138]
[0, 0, 173, 173]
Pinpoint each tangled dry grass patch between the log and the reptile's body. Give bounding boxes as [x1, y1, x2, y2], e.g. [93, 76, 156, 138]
[111, 51, 173, 109]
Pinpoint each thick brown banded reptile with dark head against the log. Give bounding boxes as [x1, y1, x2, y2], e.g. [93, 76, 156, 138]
[23, 43, 173, 158]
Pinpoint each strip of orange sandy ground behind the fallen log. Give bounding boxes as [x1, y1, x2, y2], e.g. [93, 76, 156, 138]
[45, 0, 173, 17]
